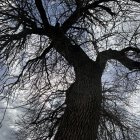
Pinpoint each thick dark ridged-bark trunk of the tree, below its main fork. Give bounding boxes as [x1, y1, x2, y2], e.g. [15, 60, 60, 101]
[55, 63, 102, 140]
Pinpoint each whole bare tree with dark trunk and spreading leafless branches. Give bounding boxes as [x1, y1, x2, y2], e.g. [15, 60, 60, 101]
[0, 0, 140, 140]
